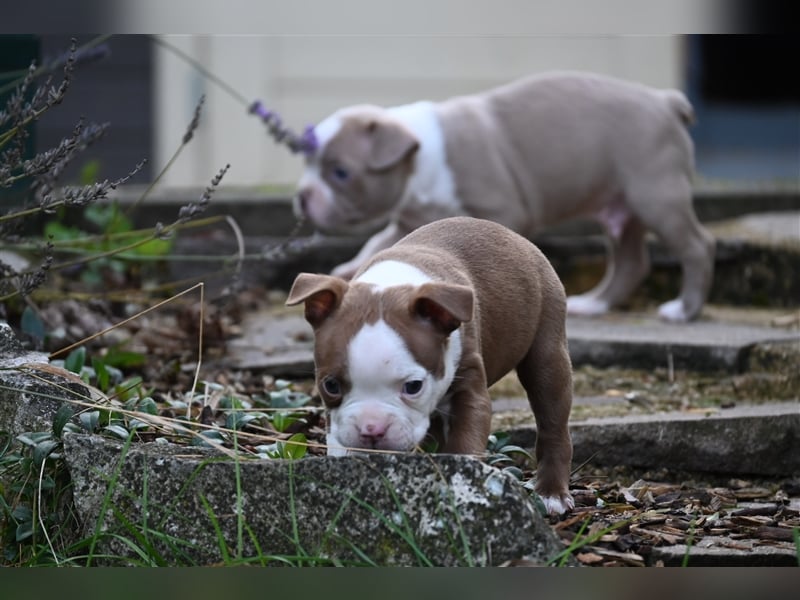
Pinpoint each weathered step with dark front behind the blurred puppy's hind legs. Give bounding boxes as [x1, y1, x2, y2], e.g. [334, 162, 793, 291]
[162, 211, 800, 310]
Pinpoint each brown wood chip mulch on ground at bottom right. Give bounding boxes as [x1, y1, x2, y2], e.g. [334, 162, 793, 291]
[554, 479, 800, 567]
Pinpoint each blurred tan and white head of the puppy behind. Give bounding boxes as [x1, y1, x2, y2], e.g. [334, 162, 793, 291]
[294, 106, 419, 233]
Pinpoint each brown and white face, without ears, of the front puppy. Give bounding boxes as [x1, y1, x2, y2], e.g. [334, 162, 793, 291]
[315, 284, 461, 456]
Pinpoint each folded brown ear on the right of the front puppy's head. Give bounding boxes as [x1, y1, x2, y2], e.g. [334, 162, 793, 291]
[410, 282, 475, 334]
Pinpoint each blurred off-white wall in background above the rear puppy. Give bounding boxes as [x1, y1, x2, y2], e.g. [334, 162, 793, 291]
[154, 35, 685, 186]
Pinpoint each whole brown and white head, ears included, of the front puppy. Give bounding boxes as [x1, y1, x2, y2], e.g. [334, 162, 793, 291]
[286, 273, 473, 456]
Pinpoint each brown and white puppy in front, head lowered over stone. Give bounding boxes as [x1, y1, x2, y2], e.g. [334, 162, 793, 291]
[286, 217, 573, 513]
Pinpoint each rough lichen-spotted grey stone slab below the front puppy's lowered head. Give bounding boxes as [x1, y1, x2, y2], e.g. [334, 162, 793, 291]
[64, 434, 563, 566]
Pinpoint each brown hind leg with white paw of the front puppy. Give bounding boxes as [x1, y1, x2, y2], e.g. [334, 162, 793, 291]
[517, 306, 575, 514]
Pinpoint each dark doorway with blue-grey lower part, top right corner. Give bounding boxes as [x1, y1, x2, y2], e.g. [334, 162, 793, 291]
[687, 35, 800, 184]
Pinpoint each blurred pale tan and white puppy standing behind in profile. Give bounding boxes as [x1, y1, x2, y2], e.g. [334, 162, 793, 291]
[295, 72, 714, 321]
